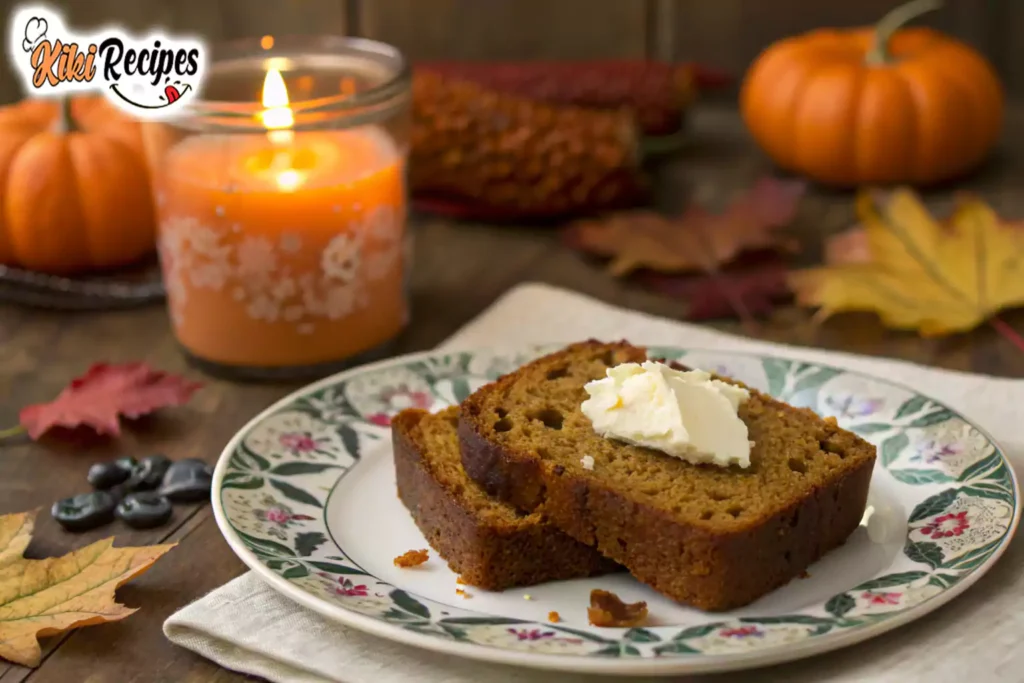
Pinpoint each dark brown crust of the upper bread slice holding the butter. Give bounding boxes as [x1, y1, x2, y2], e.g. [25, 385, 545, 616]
[459, 340, 874, 611]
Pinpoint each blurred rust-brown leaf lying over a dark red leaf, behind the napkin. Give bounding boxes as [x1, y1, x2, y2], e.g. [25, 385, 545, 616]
[565, 178, 805, 276]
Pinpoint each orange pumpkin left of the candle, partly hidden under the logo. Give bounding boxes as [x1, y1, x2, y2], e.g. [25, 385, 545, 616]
[0, 98, 156, 274]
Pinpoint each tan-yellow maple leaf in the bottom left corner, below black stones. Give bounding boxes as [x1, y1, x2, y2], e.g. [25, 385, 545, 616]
[0, 512, 175, 667]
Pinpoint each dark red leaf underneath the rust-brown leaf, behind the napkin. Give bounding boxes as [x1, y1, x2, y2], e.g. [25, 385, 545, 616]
[639, 255, 792, 321]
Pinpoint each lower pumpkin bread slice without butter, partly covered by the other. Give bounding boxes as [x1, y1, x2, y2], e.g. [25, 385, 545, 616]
[391, 408, 622, 591]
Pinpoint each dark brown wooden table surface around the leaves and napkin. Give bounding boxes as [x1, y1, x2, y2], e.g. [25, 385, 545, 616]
[6, 106, 1024, 683]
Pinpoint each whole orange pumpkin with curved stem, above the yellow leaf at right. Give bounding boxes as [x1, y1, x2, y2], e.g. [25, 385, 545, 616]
[740, 0, 1004, 186]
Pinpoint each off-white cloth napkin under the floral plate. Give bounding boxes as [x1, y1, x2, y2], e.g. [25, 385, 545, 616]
[164, 285, 1024, 683]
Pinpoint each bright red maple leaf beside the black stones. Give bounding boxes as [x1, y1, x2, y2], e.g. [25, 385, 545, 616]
[18, 362, 203, 439]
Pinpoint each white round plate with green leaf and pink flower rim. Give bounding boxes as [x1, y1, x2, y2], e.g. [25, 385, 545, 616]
[213, 348, 1020, 676]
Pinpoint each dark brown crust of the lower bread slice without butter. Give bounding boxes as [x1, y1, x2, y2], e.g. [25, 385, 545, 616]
[391, 410, 623, 591]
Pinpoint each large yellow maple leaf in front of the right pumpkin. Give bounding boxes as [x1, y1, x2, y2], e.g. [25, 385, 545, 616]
[790, 189, 1024, 337]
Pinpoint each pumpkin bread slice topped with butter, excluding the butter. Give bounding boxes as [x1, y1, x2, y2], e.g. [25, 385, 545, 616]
[459, 341, 874, 611]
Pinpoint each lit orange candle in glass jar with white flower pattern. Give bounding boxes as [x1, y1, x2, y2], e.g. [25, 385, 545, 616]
[144, 36, 411, 379]
